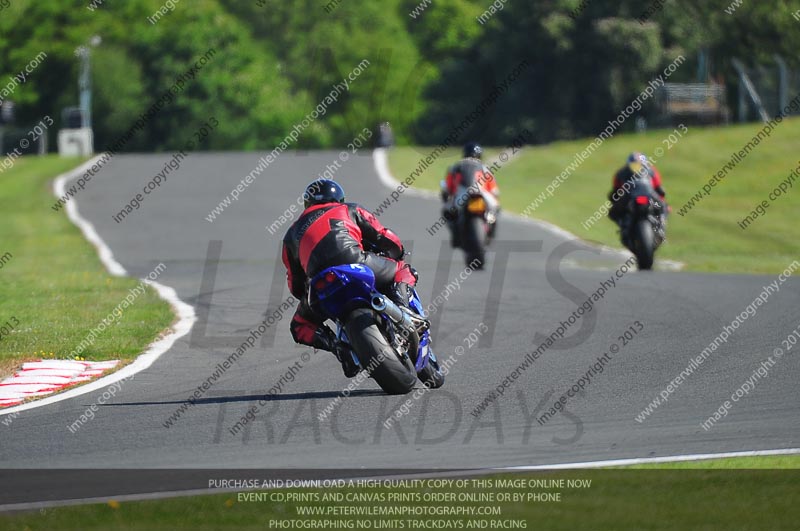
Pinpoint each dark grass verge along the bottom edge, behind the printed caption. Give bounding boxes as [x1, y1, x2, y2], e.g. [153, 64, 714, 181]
[0, 457, 800, 531]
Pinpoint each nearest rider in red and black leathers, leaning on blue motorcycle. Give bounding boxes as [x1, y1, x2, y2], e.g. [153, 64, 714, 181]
[282, 179, 417, 377]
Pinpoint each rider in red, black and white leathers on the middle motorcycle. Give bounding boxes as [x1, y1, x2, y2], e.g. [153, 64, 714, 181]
[441, 142, 500, 247]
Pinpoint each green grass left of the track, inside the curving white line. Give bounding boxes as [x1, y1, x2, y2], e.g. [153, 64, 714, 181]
[0, 156, 173, 374]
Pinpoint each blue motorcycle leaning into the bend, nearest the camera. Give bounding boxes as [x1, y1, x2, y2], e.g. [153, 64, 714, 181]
[308, 264, 444, 395]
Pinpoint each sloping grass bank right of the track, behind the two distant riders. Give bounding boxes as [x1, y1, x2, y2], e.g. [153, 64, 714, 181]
[389, 118, 800, 274]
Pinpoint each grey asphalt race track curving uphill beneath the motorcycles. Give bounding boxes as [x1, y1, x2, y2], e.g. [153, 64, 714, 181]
[0, 151, 800, 490]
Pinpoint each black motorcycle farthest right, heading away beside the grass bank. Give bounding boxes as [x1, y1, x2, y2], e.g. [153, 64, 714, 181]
[620, 178, 666, 270]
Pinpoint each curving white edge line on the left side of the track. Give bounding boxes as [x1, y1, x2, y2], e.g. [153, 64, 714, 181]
[0, 155, 197, 416]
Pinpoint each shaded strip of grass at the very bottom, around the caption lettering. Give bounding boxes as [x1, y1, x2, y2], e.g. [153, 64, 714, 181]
[0, 464, 800, 531]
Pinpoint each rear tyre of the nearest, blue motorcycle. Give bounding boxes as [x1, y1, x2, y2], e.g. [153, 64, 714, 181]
[345, 308, 417, 395]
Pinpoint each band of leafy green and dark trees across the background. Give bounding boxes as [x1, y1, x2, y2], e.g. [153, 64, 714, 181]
[0, 0, 800, 151]
